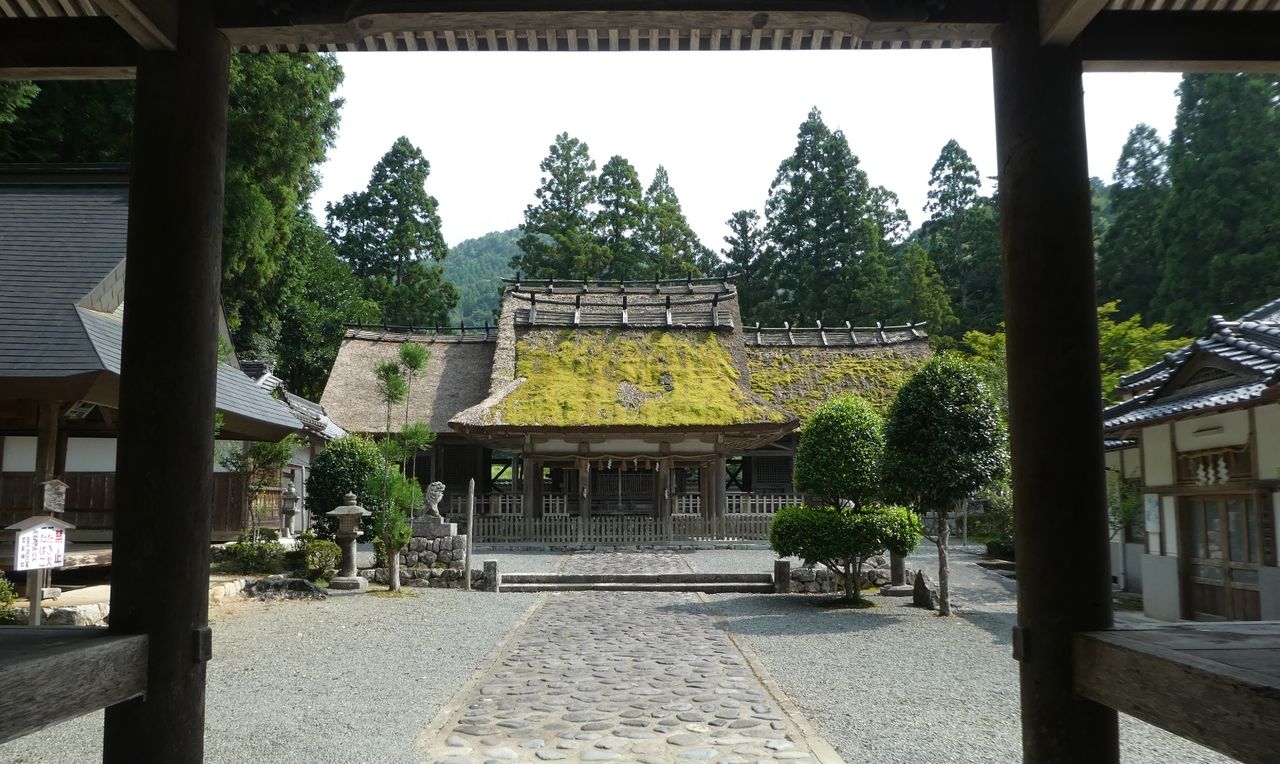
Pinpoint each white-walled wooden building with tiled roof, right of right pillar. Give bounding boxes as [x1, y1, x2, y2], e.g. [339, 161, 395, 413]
[1103, 294, 1280, 621]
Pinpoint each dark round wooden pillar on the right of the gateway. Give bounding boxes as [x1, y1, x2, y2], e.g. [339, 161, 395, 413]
[992, 3, 1119, 763]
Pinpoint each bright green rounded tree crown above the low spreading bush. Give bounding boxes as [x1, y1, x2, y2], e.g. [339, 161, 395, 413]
[795, 395, 884, 509]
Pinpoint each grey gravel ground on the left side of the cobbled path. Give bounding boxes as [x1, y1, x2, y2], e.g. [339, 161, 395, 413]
[0, 589, 534, 764]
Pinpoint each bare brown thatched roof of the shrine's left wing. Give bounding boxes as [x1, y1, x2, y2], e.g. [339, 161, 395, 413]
[320, 330, 495, 434]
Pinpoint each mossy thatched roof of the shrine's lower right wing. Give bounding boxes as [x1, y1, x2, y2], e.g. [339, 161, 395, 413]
[746, 340, 931, 421]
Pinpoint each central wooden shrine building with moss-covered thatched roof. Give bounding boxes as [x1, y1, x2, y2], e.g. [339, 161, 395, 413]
[321, 279, 929, 543]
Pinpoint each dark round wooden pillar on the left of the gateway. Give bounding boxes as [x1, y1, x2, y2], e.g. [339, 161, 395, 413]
[102, 0, 229, 763]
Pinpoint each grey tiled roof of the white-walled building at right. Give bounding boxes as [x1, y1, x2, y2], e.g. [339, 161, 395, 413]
[1102, 299, 1280, 430]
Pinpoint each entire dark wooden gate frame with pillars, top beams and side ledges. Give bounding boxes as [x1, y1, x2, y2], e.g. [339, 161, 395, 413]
[0, 0, 1280, 763]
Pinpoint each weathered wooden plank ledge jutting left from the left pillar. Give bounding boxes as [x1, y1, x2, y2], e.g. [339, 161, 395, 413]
[0, 626, 147, 744]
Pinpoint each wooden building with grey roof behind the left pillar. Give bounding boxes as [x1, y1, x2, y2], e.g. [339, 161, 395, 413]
[0, 166, 302, 542]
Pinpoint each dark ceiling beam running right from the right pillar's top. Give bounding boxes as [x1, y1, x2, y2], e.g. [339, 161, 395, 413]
[1079, 10, 1280, 72]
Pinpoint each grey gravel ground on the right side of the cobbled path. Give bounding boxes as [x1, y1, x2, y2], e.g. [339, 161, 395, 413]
[686, 546, 1231, 764]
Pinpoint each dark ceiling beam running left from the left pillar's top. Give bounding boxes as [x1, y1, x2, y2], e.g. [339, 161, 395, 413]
[0, 17, 140, 79]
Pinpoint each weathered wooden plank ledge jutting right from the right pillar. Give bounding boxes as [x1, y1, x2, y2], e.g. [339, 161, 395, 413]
[1074, 623, 1280, 764]
